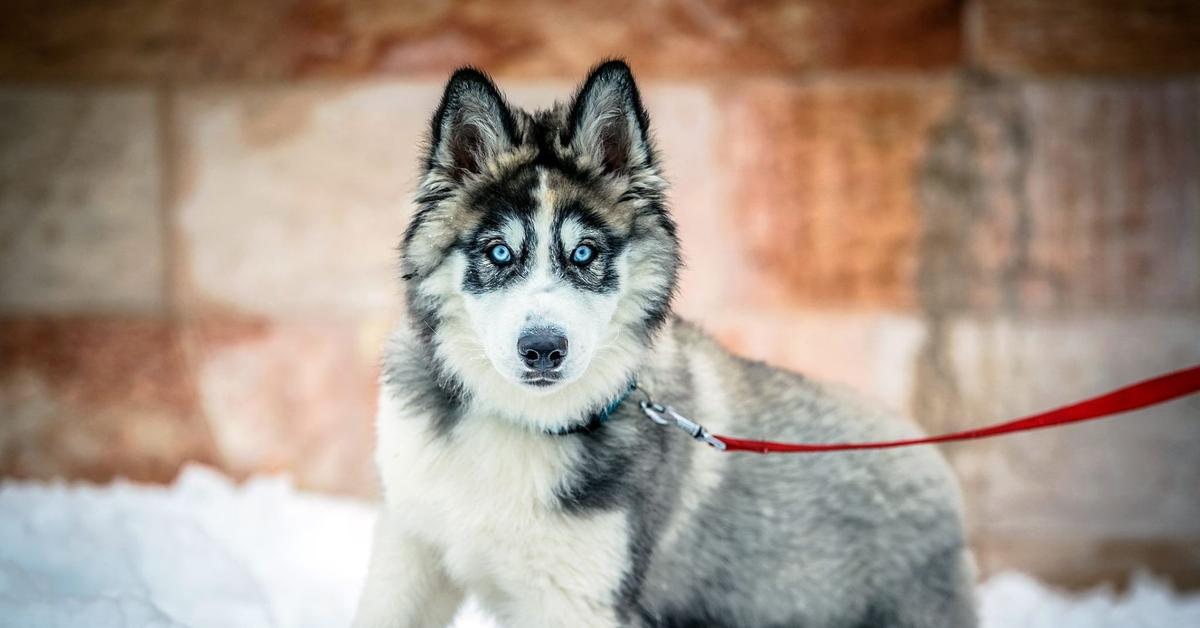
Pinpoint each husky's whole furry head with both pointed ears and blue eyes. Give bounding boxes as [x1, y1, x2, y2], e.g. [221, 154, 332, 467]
[402, 61, 679, 427]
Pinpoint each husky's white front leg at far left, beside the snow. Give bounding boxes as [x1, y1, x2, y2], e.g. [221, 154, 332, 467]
[354, 507, 463, 628]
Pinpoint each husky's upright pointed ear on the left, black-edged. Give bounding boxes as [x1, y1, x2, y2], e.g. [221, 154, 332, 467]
[428, 67, 516, 179]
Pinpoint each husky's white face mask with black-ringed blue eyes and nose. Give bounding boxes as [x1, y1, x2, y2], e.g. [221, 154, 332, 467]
[460, 166, 623, 391]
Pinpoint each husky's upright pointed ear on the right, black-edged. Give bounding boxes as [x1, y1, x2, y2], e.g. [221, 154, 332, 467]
[568, 61, 654, 173]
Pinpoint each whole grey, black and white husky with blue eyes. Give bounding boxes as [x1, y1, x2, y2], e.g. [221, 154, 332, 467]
[355, 61, 976, 628]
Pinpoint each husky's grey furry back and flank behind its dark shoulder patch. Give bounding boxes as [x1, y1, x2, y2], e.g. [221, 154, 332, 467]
[619, 322, 974, 628]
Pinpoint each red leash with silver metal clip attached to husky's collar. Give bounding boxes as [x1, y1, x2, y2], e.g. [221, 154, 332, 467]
[642, 365, 1200, 454]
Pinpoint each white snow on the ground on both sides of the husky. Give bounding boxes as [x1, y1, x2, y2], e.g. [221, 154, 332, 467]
[0, 466, 1200, 628]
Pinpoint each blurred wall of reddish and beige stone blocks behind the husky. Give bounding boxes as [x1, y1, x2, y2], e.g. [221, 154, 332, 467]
[0, 0, 1200, 588]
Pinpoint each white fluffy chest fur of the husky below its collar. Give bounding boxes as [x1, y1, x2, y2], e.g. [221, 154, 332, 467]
[377, 393, 628, 626]
